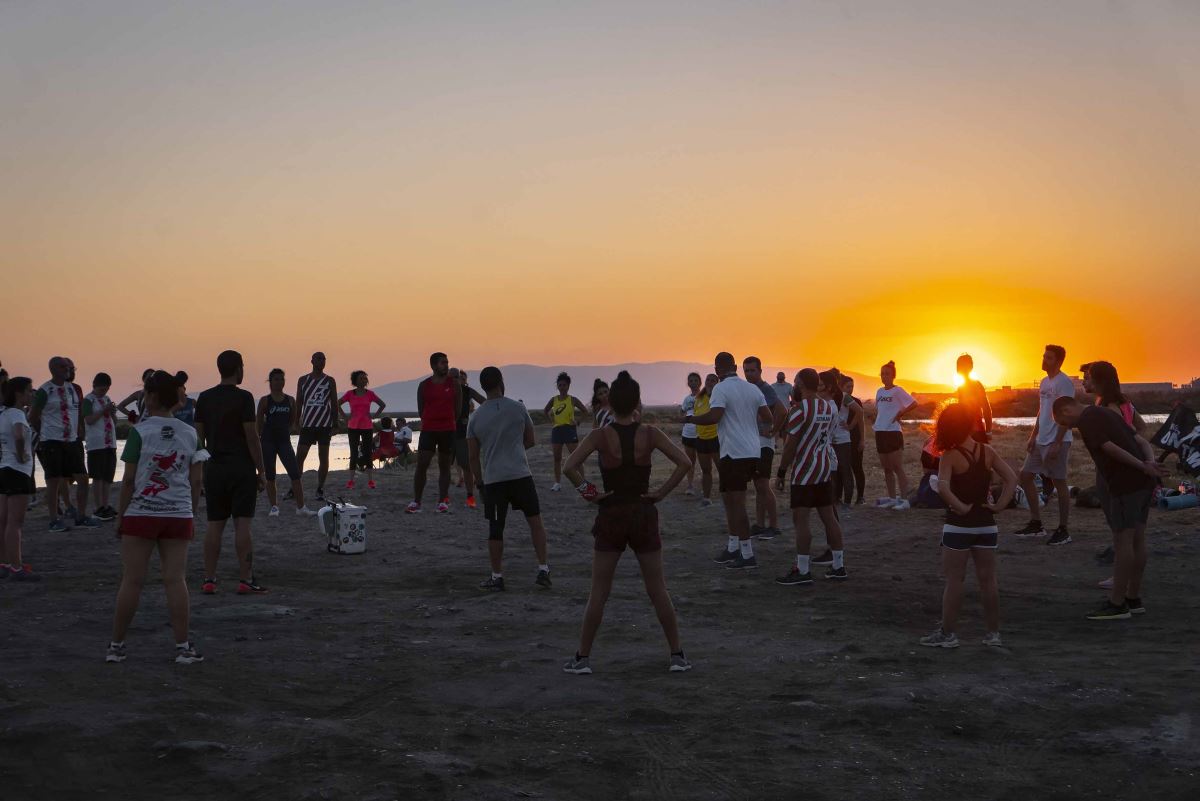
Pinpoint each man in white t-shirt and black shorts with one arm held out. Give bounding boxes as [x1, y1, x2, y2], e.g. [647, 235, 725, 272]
[691, 351, 774, 570]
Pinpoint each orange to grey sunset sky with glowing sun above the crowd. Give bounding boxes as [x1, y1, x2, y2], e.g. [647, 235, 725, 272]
[0, 0, 1200, 395]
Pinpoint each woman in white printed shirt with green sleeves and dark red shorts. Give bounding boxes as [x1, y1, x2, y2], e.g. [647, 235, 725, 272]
[104, 371, 208, 664]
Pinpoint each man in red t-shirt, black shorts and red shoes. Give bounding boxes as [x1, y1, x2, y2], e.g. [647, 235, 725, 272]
[404, 353, 462, 514]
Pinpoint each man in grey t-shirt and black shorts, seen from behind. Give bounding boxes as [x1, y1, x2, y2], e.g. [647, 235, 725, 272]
[467, 367, 550, 590]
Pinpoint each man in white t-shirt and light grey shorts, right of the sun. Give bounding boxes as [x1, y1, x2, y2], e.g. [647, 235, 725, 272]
[1016, 345, 1075, 546]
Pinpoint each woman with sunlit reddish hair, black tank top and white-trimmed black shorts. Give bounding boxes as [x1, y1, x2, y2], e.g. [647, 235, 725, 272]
[920, 403, 1016, 648]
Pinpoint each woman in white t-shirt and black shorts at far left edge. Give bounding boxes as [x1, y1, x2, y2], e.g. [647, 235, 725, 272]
[0, 377, 41, 582]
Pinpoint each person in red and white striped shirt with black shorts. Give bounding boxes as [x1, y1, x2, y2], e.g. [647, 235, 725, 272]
[775, 367, 846, 585]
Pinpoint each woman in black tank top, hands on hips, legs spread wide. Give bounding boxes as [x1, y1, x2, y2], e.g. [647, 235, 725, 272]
[563, 371, 691, 674]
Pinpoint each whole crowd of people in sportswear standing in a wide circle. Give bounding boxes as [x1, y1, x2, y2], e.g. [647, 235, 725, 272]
[0, 345, 1165, 674]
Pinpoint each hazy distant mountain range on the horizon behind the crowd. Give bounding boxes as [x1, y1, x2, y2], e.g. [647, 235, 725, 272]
[373, 361, 948, 414]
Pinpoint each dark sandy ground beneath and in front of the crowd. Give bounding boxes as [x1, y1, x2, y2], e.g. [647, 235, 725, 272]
[0, 429, 1200, 801]
